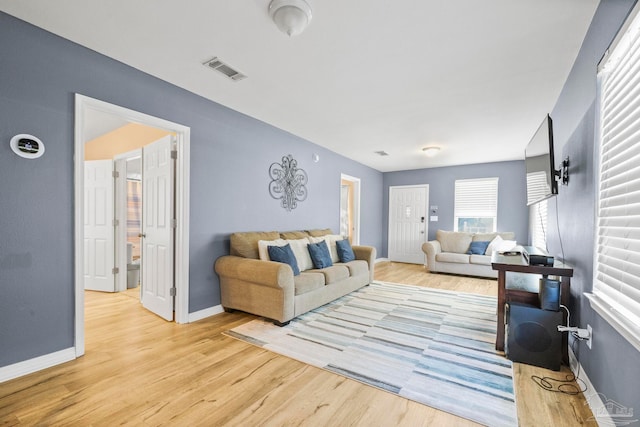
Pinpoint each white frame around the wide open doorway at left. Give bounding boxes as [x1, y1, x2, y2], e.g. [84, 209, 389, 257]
[74, 93, 191, 357]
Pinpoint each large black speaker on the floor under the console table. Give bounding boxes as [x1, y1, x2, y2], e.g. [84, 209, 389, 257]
[505, 303, 562, 371]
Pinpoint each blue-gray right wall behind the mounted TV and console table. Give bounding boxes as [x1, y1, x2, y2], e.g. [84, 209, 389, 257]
[548, 0, 640, 418]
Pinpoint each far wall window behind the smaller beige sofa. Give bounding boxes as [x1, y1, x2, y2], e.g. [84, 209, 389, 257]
[453, 178, 498, 233]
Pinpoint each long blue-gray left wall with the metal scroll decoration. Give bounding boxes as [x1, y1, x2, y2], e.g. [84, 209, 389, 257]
[0, 12, 383, 367]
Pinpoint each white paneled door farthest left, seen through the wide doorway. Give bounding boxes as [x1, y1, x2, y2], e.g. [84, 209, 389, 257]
[83, 160, 115, 292]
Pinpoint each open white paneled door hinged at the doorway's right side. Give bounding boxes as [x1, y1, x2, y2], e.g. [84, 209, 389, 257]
[141, 135, 175, 320]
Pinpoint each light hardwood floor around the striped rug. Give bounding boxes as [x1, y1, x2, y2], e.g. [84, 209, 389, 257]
[0, 263, 596, 426]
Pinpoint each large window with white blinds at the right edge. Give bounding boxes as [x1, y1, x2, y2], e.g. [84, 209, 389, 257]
[587, 7, 640, 350]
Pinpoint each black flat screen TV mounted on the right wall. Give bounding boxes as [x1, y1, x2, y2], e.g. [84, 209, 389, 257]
[524, 114, 558, 206]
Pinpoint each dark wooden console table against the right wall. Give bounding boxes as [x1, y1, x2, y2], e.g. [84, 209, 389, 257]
[491, 251, 573, 363]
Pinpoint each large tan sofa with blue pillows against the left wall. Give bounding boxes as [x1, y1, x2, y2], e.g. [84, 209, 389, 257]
[215, 229, 376, 325]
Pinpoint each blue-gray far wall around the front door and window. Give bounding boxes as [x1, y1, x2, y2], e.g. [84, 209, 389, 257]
[382, 160, 529, 256]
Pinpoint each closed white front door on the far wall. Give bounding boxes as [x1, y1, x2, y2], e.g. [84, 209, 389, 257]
[388, 185, 429, 264]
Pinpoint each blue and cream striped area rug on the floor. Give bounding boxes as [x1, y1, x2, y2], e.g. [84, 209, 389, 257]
[227, 282, 518, 426]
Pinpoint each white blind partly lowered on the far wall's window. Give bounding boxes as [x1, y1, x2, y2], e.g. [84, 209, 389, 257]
[454, 178, 498, 231]
